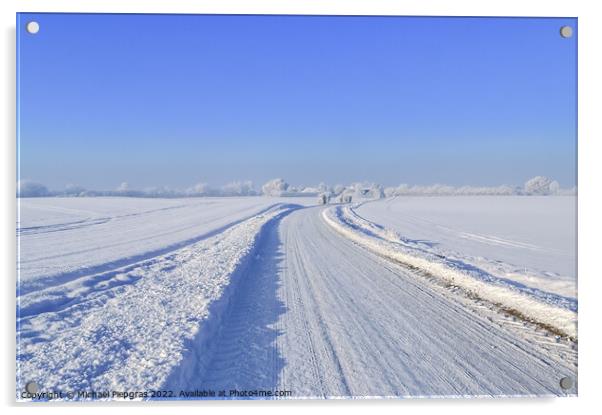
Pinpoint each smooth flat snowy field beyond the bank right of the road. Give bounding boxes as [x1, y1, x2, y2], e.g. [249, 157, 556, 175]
[354, 196, 577, 299]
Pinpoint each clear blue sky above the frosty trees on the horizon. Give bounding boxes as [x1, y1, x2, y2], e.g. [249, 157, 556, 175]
[17, 14, 577, 189]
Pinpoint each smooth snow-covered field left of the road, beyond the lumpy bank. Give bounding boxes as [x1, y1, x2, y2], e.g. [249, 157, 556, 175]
[17, 197, 315, 293]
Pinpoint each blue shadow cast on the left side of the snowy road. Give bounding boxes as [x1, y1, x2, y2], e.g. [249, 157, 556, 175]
[162, 205, 302, 399]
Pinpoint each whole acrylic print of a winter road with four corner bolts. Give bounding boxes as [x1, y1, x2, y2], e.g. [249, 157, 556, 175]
[16, 13, 578, 401]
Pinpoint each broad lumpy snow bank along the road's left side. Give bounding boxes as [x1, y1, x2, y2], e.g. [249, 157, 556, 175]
[17, 206, 288, 399]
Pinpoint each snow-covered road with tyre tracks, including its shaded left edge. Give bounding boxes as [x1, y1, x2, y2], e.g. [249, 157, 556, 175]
[171, 208, 576, 397]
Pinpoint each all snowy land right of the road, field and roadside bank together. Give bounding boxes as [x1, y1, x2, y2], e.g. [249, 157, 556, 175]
[324, 196, 577, 337]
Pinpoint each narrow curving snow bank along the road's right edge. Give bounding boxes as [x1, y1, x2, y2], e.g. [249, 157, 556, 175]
[322, 206, 577, 338]
